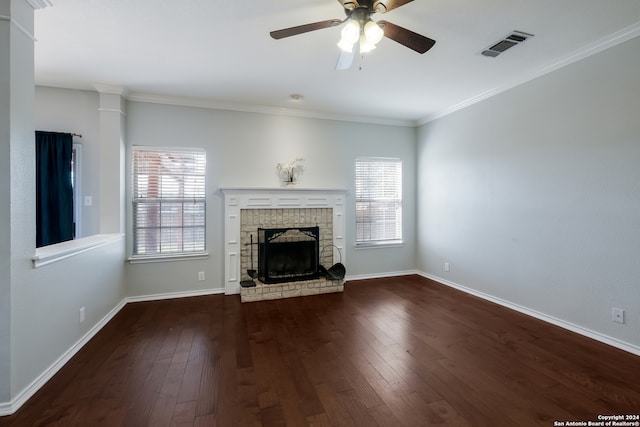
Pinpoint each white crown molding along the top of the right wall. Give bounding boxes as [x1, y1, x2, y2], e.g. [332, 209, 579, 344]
[417, 22, 640, 126]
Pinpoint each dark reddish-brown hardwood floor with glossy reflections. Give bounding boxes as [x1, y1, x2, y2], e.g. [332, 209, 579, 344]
[0, 276, 640, 427]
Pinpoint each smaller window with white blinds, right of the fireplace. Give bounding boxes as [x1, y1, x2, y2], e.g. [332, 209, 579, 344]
[356, 158, 402, 245]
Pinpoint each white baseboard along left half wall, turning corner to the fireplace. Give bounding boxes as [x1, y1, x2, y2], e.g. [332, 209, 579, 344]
[0, 289, 224, 417]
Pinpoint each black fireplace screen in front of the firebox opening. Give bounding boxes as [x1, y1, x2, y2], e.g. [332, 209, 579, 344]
[258, 227, 320, 283]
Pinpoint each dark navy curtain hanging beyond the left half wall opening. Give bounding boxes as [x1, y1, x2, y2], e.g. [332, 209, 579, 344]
[36, 131, 74, 248]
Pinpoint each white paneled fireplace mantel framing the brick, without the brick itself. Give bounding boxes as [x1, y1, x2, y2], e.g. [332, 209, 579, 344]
[220, 187, 347, 295]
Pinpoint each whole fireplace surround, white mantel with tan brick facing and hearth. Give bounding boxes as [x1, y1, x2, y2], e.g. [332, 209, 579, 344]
[222, 188, 346, 302]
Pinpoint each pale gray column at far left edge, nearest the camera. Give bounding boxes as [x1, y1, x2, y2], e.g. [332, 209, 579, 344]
[0, 0, 46, 413]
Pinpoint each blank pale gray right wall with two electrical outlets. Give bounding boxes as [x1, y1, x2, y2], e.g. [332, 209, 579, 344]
[417, 38, 640, 346]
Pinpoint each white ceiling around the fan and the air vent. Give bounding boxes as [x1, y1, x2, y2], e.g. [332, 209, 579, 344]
[35, 0, 640, 125]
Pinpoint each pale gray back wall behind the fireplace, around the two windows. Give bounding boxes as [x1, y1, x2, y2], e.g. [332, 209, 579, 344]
[126, 102, 415, 296]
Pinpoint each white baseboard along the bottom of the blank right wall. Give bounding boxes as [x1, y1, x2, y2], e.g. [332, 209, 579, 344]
[417, 272, 640, 356]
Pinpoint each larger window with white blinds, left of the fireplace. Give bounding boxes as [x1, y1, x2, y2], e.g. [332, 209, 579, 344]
[132, 147, 206, 257]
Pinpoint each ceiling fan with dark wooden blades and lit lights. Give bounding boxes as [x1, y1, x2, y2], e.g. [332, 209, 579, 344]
[269, 0, 436, 70]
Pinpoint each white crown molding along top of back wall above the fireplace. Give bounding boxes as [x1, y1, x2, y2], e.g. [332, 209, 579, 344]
[126, 92, 416, 127]
